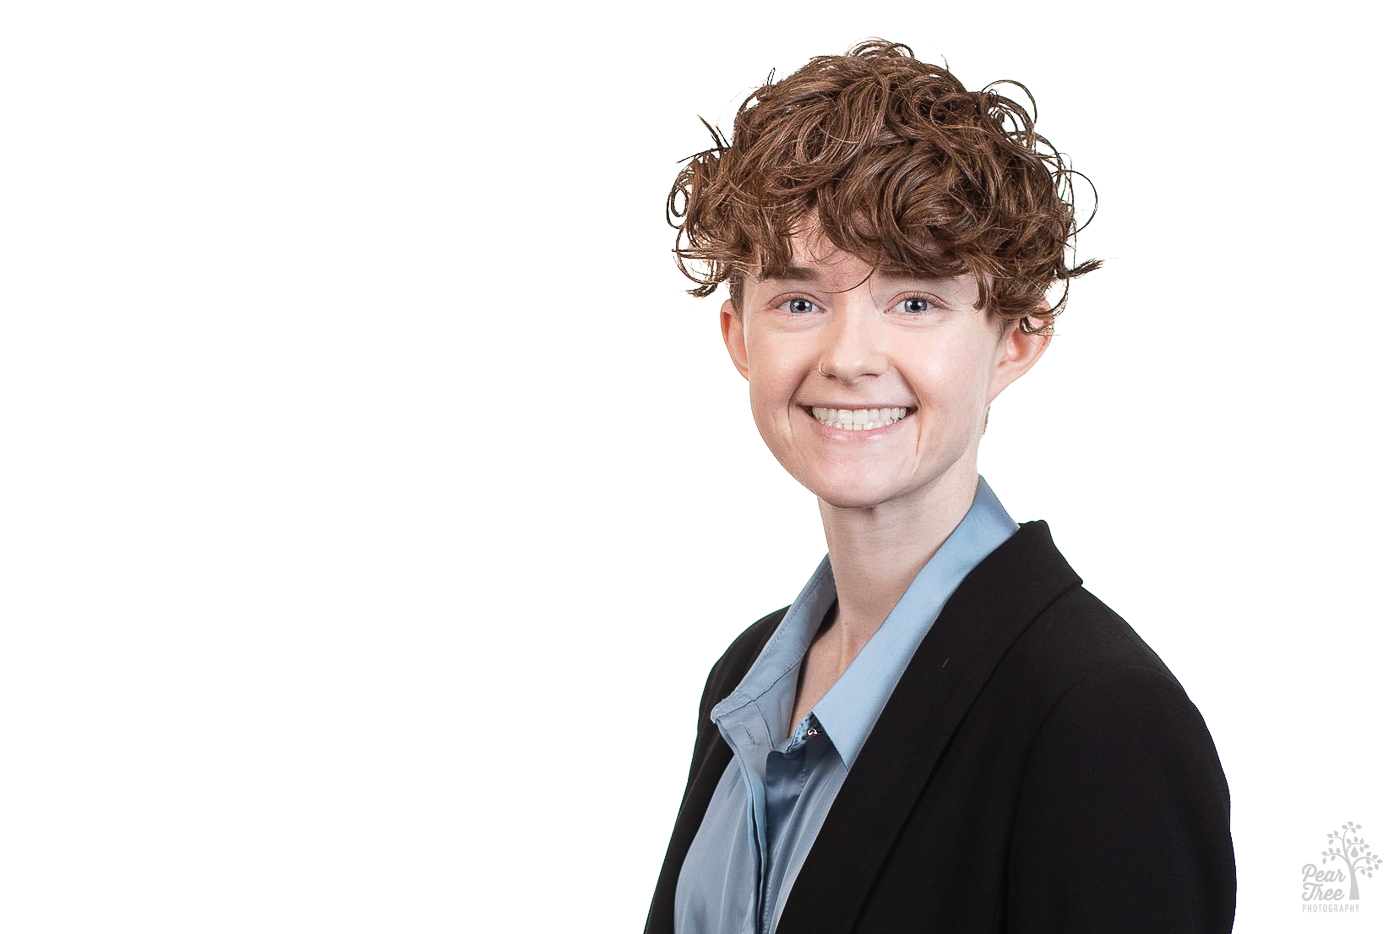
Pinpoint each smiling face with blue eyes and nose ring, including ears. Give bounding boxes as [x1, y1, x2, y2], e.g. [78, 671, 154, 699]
[721, 229, 1046, 508]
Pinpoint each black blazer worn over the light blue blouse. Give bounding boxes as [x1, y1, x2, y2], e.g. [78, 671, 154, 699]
[647, 522, 1235, 934]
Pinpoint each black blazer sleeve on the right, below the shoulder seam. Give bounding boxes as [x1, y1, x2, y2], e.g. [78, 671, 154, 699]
[1007, 667, 1235, 934]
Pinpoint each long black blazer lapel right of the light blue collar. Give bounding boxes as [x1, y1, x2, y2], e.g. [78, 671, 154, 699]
[778, 522, 1081, 934]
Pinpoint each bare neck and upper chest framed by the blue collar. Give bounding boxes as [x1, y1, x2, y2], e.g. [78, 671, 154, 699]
[822, 471, 977, 660]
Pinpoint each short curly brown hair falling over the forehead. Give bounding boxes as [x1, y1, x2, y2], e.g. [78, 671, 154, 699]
[666, 39, 1100, 332]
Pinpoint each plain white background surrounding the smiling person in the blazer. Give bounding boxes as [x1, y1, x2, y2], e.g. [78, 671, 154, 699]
[0, 0, 1400, 934]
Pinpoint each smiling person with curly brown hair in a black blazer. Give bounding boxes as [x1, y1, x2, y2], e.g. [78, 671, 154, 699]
[647, 41, 1235, 934]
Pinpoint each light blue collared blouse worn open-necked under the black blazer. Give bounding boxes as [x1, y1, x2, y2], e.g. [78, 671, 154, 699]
[676, 479, 1016, 934]
